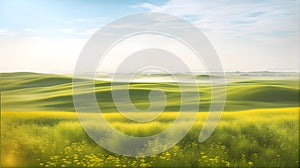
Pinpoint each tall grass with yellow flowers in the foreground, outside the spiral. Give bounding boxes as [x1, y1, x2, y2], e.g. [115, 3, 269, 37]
[1, 108, 299, 167]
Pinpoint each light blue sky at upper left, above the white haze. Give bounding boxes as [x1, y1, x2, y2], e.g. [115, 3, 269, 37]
[0, 0, 163, 36]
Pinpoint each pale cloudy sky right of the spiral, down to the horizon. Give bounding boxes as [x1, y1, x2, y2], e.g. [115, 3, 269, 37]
[134, 0, 300, 71]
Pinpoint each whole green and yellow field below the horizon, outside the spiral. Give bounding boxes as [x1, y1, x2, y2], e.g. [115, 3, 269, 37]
[1, 73, 299, 167]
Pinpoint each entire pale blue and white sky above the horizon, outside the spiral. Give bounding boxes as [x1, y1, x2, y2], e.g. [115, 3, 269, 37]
[0, 0, 300, 73]
